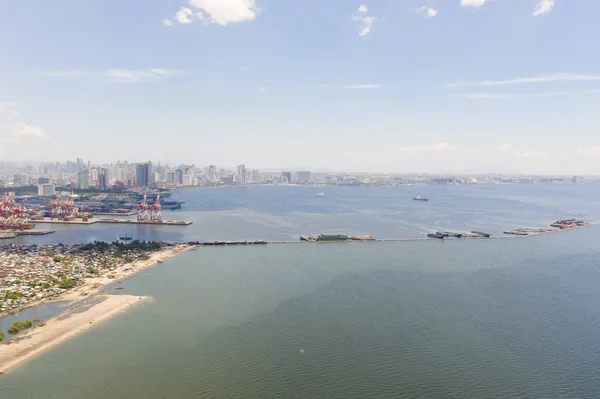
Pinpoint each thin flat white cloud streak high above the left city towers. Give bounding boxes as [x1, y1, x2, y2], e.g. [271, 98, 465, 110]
[39, 68, 185, 83]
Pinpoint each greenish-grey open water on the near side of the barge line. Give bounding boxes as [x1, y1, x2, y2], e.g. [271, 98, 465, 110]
[0, 226, 600, 399]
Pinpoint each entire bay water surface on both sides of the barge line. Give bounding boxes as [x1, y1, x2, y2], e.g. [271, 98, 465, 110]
[0, 185, 600, 399]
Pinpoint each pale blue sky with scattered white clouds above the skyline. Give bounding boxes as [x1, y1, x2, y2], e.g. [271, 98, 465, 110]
[0, 0, 600, 174]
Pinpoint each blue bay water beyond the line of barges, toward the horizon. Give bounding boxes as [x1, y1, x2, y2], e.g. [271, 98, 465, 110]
[3, 184, 600, 243]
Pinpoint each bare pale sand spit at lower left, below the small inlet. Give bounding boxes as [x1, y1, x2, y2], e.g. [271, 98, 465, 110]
[0, 295, 147, 371]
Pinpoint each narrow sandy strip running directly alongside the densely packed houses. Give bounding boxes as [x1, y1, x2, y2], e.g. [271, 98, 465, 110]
[0, 244, 195, 319]
